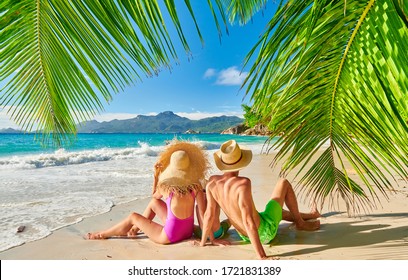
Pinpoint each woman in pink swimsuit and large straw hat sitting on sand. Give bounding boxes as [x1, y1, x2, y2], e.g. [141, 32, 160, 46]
[87, 141, 209, 244]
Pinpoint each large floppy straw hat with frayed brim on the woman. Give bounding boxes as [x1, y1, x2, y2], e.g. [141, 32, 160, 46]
[157, 140, 210, 194]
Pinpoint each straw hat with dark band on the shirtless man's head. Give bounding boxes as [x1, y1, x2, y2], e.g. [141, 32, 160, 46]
[214, 140, 252, 172]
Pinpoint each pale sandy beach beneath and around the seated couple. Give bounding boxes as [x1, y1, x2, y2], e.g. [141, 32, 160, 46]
[0, 151, 408, 260]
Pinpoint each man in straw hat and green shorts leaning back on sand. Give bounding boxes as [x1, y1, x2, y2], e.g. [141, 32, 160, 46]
[200, 140, 320, 259]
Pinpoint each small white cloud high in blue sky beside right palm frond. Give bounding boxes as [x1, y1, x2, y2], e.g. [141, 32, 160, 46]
[204, 66, 248, 86]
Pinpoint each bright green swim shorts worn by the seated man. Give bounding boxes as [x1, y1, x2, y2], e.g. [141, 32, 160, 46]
[239, 199, 282, 244]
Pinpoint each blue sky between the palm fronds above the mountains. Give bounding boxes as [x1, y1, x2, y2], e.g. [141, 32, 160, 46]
[0, 1, 276, 128]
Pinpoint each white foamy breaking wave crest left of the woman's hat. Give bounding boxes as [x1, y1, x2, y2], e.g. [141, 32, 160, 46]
[0, 143, 162, 169]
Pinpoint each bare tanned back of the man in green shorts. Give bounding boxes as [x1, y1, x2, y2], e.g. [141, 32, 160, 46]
[207, 173, 260, 236]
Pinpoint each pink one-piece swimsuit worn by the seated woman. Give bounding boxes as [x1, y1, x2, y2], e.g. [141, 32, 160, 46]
[164, 192, 195, 243]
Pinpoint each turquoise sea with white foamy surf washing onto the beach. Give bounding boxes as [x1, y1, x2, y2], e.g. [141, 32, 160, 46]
[0, 134, 267, 251]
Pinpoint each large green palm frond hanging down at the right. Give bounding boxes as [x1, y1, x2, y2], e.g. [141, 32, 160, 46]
[247, 0, 408, 210]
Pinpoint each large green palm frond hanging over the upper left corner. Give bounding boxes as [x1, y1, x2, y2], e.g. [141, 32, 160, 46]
[0, 0, 210, 144]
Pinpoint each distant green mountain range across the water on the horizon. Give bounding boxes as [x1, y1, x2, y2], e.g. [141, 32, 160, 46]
[78, 111, 244, 133]
